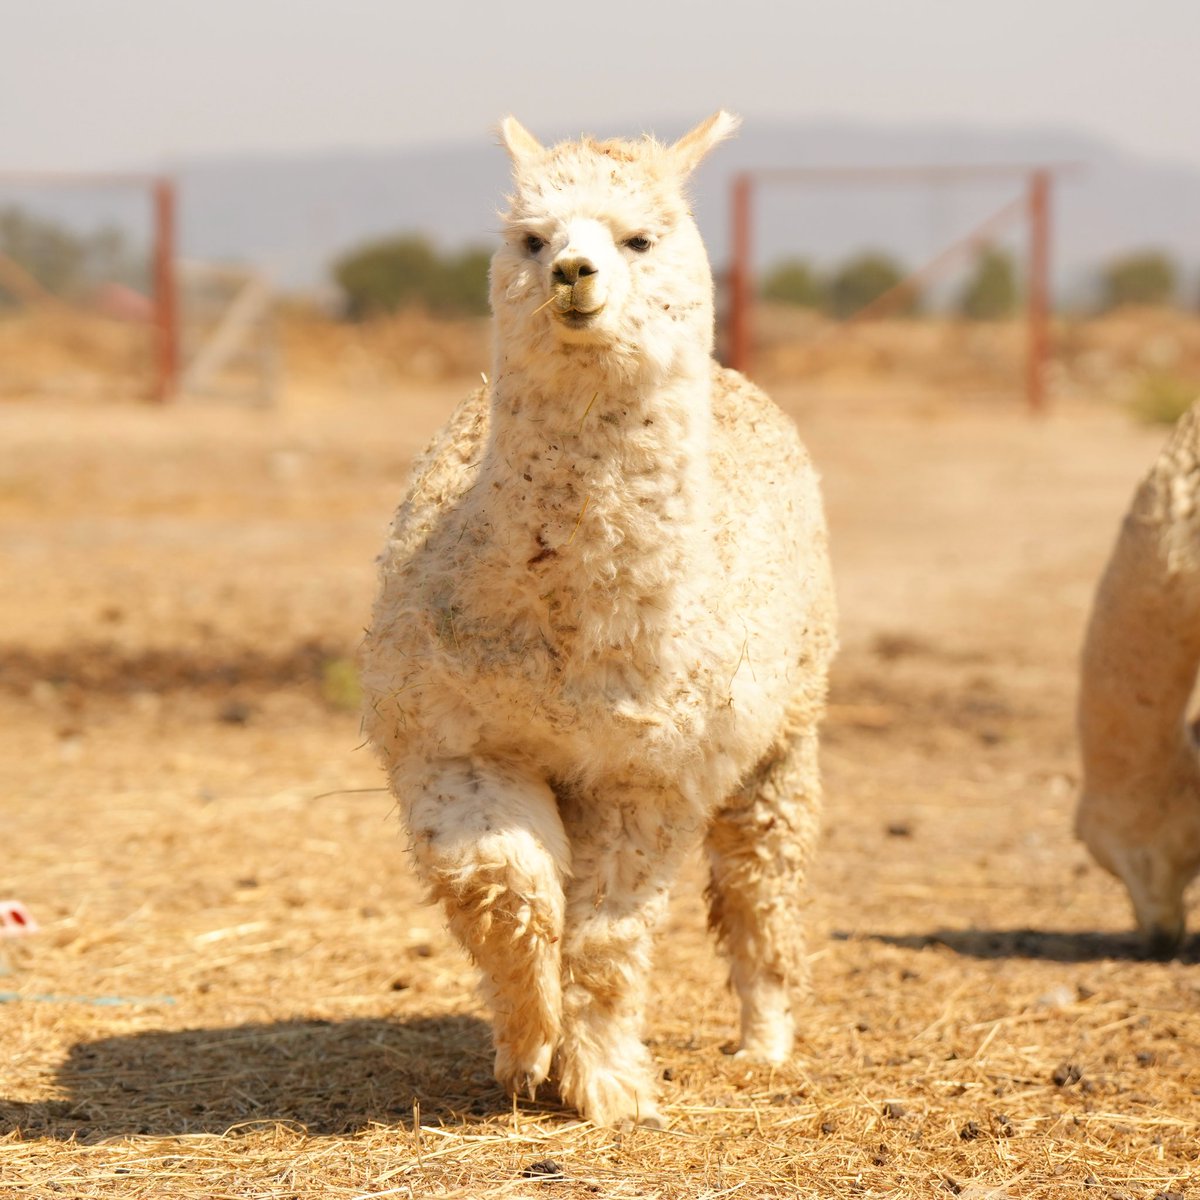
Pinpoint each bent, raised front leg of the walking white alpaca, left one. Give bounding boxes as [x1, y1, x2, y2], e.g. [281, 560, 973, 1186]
[395, 757, 570, 1098]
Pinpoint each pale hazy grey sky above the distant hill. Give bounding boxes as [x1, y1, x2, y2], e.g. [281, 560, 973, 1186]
[0, 0, 1200, 171]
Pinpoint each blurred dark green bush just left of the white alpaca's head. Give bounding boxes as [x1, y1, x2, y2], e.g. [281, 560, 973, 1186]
[332, 234, 491, 320]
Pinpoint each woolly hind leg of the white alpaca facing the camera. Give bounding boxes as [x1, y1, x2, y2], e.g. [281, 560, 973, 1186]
[707, 734, 821, 1062]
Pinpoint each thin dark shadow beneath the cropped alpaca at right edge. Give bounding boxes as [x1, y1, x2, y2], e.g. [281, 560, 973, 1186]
[833, 929, 1200, 962]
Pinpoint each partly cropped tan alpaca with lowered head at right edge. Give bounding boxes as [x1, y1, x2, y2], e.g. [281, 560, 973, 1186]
[1075, 406, 1200, 958]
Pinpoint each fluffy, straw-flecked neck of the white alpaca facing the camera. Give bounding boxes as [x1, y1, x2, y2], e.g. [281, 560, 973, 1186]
[473, 356, 710, 648]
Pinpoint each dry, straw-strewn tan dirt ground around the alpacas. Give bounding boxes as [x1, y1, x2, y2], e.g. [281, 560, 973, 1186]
[0, 319, 1200, 1200]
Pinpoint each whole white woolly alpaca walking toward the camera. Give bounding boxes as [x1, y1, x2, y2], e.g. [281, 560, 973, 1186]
[364, 113, 834, 1123]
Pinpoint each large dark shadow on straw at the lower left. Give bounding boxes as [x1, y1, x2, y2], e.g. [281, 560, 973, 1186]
[0, 1015, 535, 1142]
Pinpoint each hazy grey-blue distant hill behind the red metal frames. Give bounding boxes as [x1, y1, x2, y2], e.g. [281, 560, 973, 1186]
[0, 119, 1200, 300]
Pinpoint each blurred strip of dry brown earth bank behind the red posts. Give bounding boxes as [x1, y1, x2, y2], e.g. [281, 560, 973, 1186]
[7, 301, 1200, 424]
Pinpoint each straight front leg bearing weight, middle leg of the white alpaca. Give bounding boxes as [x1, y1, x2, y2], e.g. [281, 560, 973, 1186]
[559, 790, 700, 1126]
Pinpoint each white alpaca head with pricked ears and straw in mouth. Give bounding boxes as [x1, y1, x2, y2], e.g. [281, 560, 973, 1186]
[491, 113, 737, 373]
